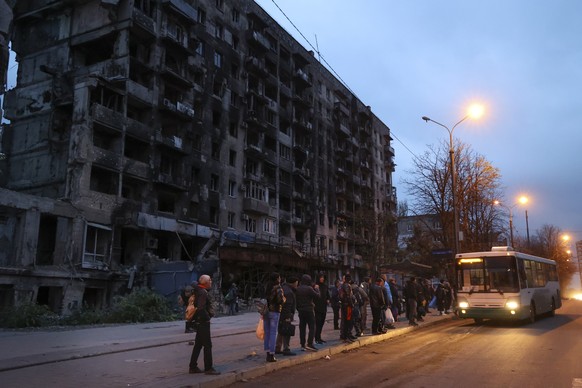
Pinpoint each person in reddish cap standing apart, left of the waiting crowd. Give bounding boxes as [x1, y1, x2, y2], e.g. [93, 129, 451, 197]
[189, 275, 220, 375]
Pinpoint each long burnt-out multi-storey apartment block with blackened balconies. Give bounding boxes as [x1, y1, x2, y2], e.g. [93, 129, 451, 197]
[0, 0, 396, 314]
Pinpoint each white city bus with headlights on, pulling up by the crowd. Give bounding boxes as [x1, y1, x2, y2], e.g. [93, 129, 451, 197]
[455, 247, 562, 323]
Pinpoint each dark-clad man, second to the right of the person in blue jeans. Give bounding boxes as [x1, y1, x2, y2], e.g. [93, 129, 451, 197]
[295, 274, 319, 352]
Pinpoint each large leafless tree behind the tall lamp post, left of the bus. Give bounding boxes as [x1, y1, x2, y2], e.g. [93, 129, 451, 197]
[403, 140, 502, 252]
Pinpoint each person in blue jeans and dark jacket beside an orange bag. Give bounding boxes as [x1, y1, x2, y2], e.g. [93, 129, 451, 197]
[263, 272, 285, 362]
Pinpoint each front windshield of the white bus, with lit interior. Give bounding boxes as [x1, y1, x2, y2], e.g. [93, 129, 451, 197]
[457, 256, 519, 293]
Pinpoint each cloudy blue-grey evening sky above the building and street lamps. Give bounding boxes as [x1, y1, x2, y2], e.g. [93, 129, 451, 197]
[257, 0, 582, 252]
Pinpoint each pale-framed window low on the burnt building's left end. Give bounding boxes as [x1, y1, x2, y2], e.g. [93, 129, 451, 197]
[82, 222, 111, 269]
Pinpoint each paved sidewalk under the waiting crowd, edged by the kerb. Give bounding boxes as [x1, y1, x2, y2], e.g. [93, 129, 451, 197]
[0, 309, 453, 388]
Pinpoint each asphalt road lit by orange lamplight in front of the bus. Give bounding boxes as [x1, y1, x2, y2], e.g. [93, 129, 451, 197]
[233, 301, 582, 388]
